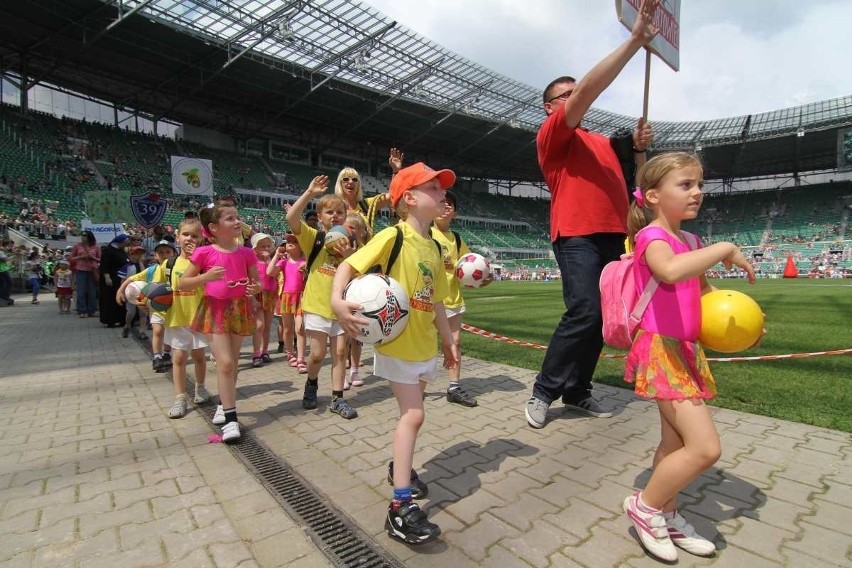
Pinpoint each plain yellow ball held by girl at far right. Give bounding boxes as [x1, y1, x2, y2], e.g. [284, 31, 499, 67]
[698, 290, 763, 353]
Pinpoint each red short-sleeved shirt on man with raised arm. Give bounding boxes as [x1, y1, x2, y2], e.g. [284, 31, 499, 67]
[536, 105, 629, 241]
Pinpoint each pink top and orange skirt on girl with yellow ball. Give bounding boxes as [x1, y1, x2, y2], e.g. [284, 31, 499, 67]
[624, 227, 716, 400]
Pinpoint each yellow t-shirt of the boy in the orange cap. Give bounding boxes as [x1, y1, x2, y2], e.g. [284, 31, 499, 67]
[346, 223, 449, 361]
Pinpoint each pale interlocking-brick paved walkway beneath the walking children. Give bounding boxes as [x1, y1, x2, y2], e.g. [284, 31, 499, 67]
[0, 295, 852, 568]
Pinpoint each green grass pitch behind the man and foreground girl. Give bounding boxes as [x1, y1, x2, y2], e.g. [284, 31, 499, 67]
[462, 280, 852, 432]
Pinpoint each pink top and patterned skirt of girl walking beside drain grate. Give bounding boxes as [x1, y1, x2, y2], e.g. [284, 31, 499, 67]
[189, 245, 257, 336]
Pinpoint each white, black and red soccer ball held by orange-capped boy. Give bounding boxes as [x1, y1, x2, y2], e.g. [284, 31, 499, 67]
[343, 274, 409, 345]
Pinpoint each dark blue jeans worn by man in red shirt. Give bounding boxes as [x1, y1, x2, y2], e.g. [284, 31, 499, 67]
[533, 233, 624, 404]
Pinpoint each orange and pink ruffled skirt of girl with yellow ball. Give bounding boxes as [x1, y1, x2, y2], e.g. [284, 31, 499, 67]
[624, 330, 716, 400]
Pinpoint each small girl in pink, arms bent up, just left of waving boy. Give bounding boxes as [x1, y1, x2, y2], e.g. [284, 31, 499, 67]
[267, 234, 308, 374]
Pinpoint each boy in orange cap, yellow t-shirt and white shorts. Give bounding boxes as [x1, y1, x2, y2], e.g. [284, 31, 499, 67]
[331, 162, 459, 544]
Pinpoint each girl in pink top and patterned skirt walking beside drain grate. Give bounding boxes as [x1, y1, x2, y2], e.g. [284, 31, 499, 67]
[178, 203, 260, 442]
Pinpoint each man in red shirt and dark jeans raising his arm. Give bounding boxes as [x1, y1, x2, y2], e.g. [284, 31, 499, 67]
[524, 0, 659, 428]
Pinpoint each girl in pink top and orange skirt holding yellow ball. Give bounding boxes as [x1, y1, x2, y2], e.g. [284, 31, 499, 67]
[623, 152, 754, 561]
